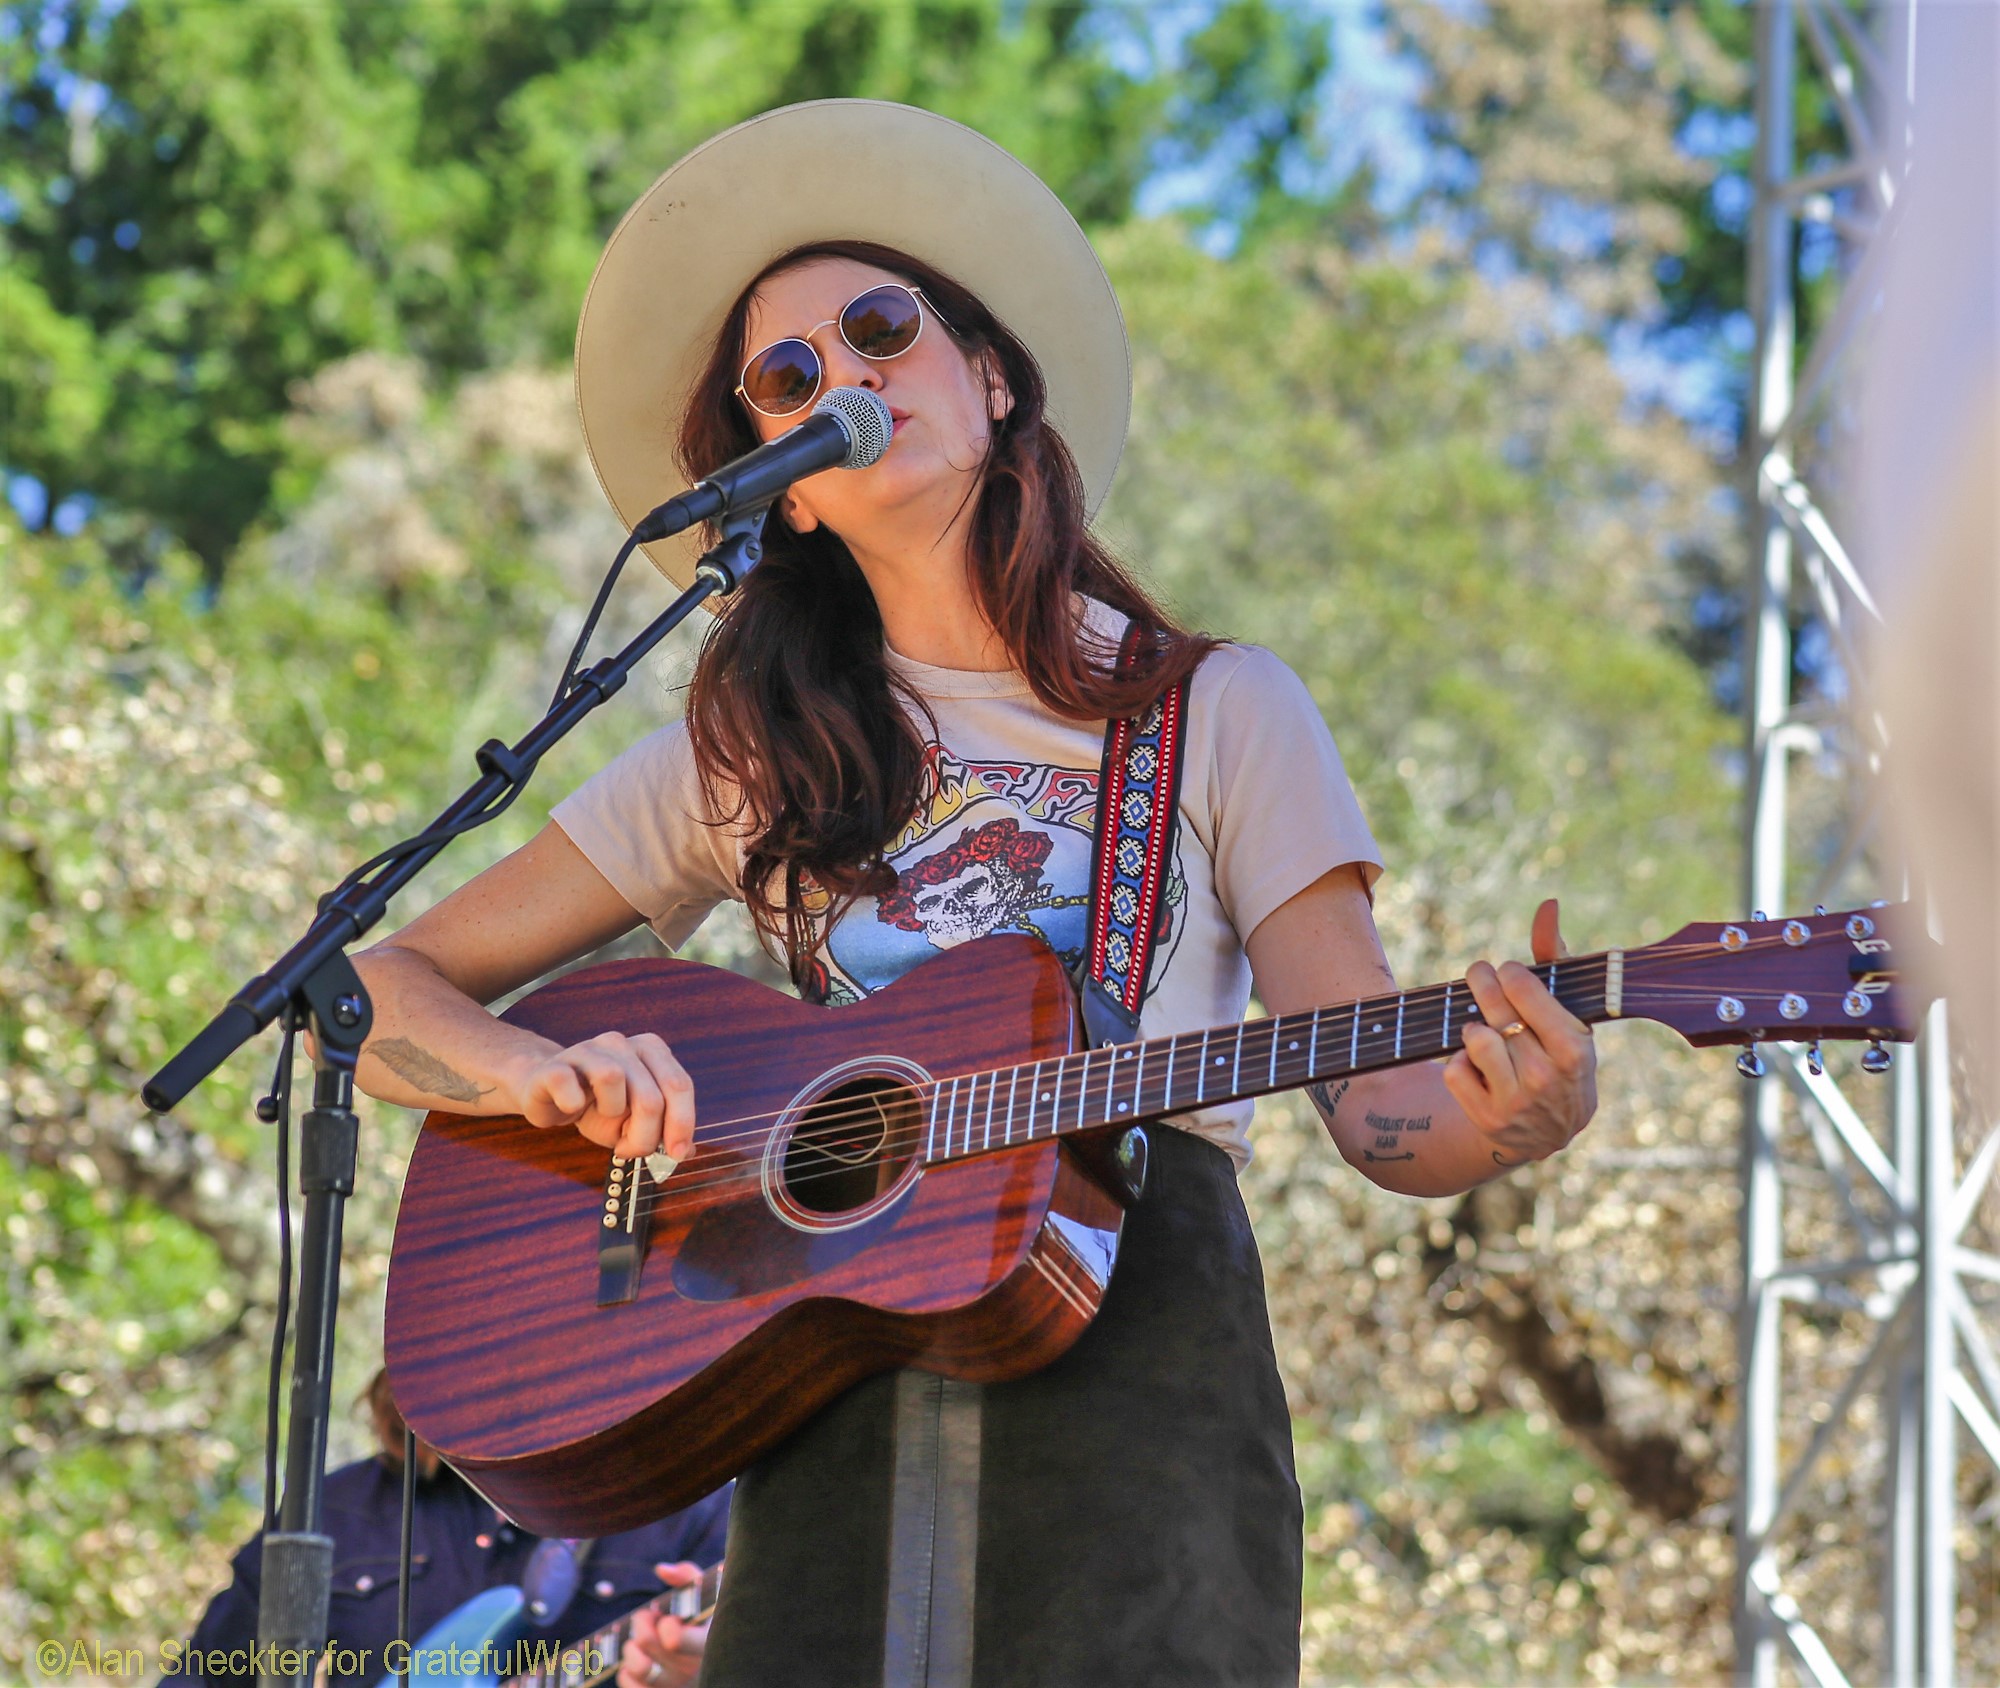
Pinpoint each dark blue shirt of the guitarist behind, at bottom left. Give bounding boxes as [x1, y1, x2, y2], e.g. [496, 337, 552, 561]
[160, 1458, 730, 1688]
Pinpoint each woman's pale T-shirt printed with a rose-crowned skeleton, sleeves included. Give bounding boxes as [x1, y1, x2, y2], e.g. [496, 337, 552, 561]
[552, 600, 1382, 1170]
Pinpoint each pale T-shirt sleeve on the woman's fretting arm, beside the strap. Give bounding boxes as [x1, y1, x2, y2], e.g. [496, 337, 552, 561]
[1184, 644, 1382, 942]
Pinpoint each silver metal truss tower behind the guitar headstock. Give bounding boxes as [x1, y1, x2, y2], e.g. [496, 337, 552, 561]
[1734, 0, 2000, 1688]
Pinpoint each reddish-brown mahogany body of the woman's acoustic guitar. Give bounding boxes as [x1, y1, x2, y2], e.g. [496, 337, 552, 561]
[386, 936, 1124, 1536]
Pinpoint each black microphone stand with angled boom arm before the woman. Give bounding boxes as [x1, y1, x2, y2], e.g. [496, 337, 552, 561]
[140, 502, 770, 1688]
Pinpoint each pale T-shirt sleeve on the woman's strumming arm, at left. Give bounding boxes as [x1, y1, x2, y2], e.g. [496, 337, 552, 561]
[550, 722, 740, 948]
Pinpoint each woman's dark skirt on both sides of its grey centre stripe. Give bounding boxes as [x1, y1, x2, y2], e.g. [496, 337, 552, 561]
[702, 1126, 1302, 1688]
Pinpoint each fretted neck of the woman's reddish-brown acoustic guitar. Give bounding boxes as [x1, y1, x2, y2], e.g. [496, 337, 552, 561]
[924, 950, 1626, 1164]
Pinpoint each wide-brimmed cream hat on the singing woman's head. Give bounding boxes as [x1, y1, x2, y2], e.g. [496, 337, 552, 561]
[576, 100, 1132, 586]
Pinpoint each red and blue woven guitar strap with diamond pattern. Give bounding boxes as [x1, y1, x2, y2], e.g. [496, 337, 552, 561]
[1084, 626, 1188, 1046]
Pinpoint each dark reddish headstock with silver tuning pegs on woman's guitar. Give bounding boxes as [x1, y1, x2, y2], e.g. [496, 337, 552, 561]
[1622, 902, 1928, 1046]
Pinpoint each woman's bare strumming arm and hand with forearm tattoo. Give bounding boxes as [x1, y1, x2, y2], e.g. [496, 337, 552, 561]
[340, 824, 694, 1160]
